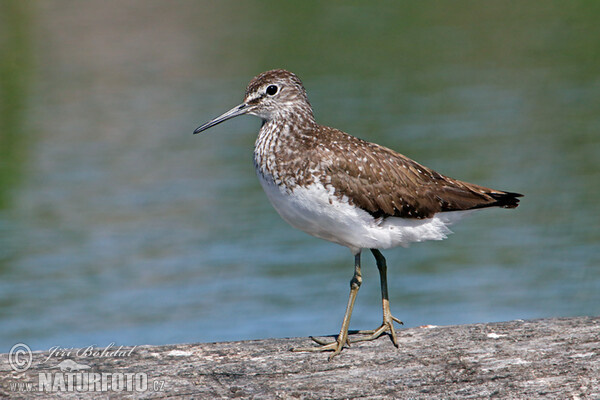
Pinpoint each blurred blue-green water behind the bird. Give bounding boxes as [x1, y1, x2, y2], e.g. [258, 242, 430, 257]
[0, 0, 600, 352]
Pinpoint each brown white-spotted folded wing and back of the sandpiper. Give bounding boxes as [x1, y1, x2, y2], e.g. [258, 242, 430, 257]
[323, 128, 521, 218]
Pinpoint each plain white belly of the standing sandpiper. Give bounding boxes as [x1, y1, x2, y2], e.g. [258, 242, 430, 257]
[258, 174, 470, 254]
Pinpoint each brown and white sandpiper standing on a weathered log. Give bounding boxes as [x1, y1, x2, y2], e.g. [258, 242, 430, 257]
[194, 69, 523, 360]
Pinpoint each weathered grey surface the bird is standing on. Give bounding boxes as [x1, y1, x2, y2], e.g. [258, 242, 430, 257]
[0, 317, 600, 399]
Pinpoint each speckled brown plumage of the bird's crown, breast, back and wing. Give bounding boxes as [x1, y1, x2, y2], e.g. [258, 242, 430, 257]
[246, 70, 521, 218]
